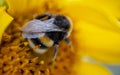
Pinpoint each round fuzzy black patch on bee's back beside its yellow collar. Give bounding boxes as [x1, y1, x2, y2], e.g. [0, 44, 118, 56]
[54, 15, 70, 31]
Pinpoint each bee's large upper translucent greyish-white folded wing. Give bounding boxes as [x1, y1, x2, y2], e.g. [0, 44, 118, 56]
[21, 19, 61, 33]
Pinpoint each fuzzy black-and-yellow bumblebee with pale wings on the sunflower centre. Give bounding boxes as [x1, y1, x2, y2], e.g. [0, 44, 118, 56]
[21, 14, 72, 60]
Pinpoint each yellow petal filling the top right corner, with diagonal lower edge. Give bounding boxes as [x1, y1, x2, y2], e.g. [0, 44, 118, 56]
[80, 0, 120, 19]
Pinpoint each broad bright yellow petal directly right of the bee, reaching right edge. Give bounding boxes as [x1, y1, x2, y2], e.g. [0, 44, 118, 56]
[75, 21, 120, 63]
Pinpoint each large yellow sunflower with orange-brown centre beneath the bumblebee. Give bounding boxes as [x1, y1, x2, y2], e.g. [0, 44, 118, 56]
[0, 0, 120, 75]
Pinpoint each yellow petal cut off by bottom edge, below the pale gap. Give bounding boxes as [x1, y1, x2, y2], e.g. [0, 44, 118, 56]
[75, 61, 112, 75]
